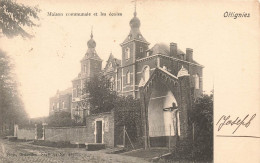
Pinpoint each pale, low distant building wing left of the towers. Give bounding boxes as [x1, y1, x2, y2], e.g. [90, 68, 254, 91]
[49, 88, 72, 115]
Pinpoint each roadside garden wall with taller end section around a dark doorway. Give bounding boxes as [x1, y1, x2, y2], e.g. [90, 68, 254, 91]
[45, 113, 114, 147]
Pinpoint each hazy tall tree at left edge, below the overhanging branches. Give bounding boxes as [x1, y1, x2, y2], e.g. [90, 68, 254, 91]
[0, 50, 28, 134]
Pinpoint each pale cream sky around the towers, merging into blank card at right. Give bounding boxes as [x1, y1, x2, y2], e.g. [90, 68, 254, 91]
[0, 0, 259, 117]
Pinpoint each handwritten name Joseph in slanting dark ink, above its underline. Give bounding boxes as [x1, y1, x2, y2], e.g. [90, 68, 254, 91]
[216, 114, 256, 134]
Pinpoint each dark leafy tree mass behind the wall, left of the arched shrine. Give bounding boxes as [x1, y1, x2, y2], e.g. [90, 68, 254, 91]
[83, 75, 143, 148]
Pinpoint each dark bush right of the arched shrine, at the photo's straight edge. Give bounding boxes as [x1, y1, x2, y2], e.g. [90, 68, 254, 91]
[191, 94, 213, 159]
